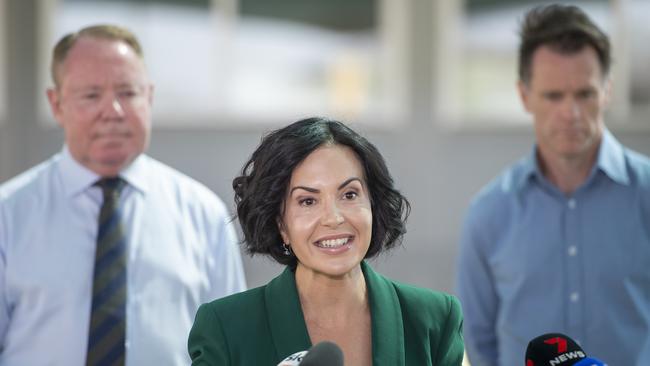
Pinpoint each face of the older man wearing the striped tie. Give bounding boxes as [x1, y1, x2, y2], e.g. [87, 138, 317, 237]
[47, 37, 153, 177]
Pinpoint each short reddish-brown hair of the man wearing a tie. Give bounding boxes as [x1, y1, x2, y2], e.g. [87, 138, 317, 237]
[50, 24, 144, 87]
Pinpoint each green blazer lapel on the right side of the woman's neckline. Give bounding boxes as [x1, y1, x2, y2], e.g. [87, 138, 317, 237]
[361, 261, 406, 366]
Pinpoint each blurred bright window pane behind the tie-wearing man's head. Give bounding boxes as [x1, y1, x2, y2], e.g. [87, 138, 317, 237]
[40, 0, 216, 126]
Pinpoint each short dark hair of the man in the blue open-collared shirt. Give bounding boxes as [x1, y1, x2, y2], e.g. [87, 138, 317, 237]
[519, 4, 611, 83]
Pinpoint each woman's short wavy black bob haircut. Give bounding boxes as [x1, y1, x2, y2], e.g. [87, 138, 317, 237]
[232, 117, 410, 268]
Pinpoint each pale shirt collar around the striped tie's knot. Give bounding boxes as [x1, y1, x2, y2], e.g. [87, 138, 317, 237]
[59, 145, 149, 197]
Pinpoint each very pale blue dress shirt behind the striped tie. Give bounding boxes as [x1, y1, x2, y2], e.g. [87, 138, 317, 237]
[0, 147, 245, 366]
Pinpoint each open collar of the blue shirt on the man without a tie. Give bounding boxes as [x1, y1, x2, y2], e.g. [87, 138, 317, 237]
[517, 129, 630, 189]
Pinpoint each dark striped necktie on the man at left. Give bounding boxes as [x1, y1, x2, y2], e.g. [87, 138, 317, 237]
[86, 178, 127, 366]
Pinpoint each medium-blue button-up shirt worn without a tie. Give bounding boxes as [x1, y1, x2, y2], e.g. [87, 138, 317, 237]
[457, 131, 650, 366]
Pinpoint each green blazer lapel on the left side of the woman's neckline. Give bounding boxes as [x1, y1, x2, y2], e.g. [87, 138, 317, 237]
[264, 267, 311, 360]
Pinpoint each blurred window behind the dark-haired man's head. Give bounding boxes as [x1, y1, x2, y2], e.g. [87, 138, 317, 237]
[433, 0, 650, 128]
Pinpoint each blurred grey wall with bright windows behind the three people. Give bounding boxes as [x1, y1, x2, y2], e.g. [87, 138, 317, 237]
[0, 0, 650, 291]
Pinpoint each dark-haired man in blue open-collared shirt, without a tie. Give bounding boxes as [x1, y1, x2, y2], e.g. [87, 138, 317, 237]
[457, 5, 650, 366]
